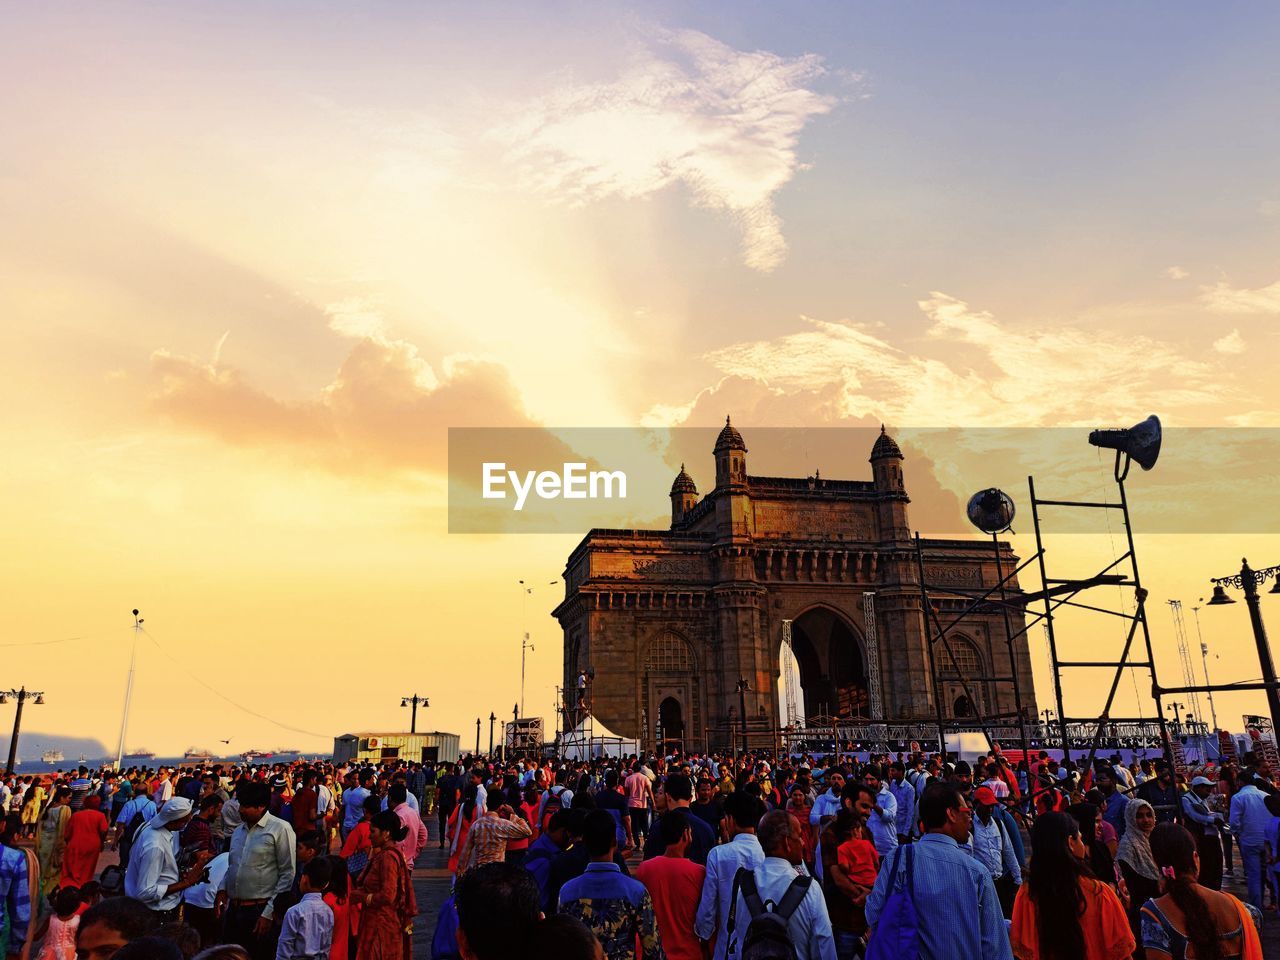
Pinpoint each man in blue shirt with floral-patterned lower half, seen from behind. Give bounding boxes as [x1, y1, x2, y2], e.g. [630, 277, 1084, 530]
[559, 810, 663, 960]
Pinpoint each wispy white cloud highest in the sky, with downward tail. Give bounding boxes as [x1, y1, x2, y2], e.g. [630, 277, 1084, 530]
[494, 31, 849, 271]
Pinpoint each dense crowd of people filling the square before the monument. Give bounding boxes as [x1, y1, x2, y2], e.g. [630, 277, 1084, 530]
[0, 749, 1280, 960]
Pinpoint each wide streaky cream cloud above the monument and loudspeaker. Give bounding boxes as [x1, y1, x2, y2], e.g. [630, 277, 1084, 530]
[662, 293, 1234, 426]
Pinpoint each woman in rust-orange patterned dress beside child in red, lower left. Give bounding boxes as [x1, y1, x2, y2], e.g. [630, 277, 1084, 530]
[352, 810, 417, 960]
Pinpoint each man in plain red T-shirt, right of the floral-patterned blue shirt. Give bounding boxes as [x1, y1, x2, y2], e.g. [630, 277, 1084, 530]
[635, 808, 707, 960]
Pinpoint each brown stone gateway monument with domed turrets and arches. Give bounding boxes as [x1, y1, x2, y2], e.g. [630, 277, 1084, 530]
[553, 417, 1037, 751]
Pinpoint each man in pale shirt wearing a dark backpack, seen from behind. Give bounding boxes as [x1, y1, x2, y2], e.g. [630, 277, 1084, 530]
[724, 810, 836, 960]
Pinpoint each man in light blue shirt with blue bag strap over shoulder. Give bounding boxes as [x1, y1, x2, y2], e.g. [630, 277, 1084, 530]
[867, 782, 1014, 960]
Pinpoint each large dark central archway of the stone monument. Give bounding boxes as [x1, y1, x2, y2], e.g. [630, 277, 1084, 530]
[791, 607, 870, 717]
